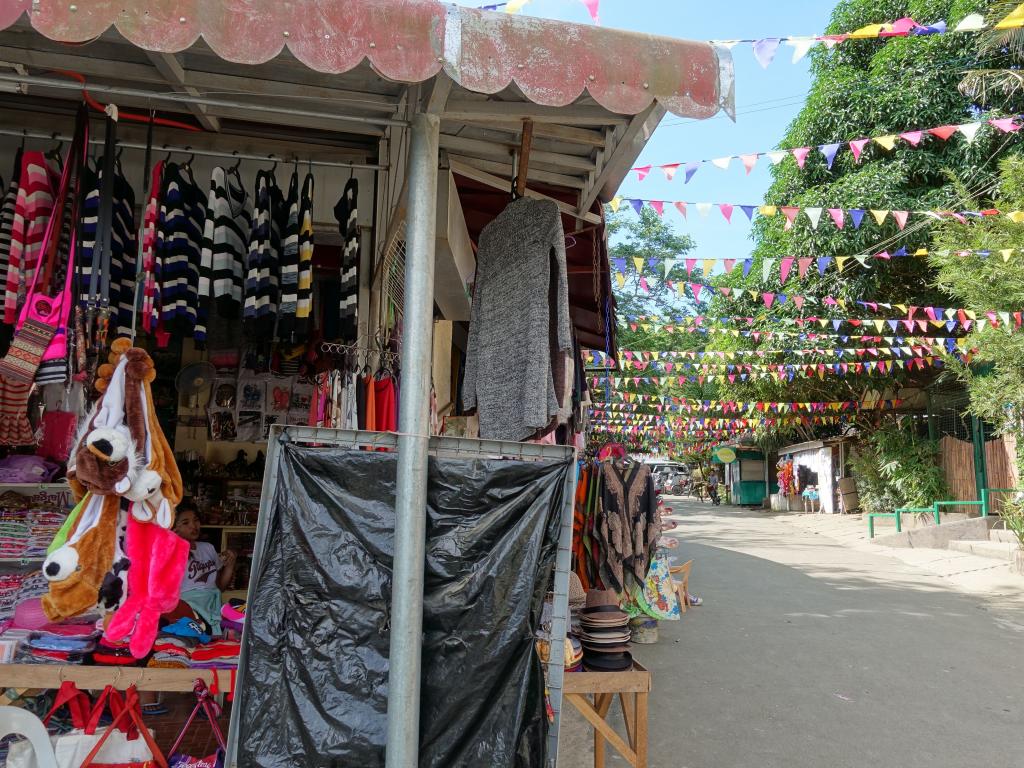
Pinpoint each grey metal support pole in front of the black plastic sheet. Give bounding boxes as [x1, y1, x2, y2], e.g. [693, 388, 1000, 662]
[386, 114, 440, 768]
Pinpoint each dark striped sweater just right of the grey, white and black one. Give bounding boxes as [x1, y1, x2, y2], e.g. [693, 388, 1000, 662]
[243, 171, 287, 339]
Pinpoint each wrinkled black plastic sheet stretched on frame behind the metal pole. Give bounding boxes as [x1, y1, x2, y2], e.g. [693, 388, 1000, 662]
[238, 443, 572, 768]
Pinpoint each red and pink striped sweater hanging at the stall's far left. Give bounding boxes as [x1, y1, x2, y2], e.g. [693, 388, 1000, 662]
[3, 152, 59, 324]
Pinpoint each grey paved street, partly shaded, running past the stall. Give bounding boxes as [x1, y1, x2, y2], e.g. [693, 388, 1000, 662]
[559, 499, 1024, 768]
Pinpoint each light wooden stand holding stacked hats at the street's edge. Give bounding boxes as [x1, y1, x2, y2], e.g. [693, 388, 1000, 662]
[562, 662, 651, 768]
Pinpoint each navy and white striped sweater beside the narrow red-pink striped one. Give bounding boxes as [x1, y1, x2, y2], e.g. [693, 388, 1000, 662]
[157, 163, 206, 336]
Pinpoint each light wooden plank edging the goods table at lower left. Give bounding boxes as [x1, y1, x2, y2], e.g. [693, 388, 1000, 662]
[0, 664, 231, 692]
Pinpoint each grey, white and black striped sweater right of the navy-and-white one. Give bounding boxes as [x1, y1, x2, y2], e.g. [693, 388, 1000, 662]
[196, 167, 253, 341]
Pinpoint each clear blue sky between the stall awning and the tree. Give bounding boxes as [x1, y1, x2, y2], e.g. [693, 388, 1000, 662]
[459, 0, 834, 258]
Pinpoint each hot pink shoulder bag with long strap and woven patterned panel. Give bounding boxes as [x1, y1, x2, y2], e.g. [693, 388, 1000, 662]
[0, 108, 89, 384]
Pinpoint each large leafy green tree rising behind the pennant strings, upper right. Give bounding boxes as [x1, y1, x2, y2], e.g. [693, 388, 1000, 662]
[713, 0, 1017, 428]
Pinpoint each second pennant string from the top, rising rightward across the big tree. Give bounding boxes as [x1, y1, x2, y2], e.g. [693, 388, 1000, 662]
[631, 115, 1022, 182]
